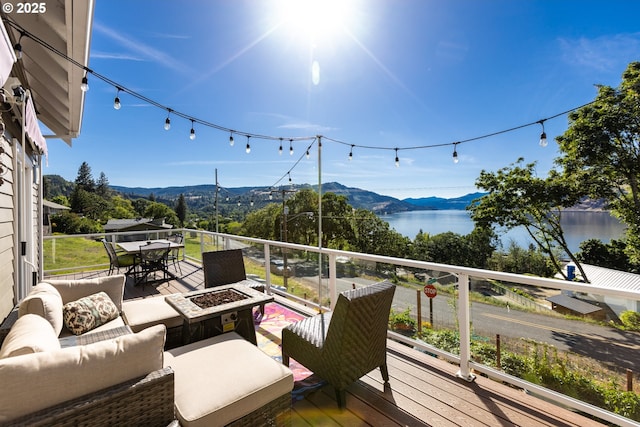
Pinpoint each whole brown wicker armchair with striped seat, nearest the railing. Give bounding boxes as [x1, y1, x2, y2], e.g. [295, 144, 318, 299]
[282, 281, 395, 408]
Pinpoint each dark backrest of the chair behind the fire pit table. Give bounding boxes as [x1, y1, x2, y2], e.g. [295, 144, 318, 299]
[202, 249, 247, 288]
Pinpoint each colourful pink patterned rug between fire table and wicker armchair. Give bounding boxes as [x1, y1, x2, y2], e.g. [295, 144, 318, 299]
[256, 303, 326, 400]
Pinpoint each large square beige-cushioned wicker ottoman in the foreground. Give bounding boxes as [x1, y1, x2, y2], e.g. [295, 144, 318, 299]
[164, 332, 293, 426]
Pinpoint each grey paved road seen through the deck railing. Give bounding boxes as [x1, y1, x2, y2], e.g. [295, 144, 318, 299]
[330, 277, 640, 373]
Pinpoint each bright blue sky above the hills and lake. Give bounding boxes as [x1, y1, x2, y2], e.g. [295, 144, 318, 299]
[43, 0, 640, 198]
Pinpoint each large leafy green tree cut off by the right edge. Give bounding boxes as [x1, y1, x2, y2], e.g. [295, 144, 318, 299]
[556, 62, 640, 264]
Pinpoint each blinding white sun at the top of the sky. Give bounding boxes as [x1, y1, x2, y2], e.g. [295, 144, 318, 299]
[277, 0, 352, 43]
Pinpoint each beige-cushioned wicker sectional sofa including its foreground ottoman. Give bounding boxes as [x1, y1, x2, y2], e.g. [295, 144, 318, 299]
[0, 276, 293, 426]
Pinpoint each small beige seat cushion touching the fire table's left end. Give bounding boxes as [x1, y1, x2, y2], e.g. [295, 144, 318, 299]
[122, 296, 182, 332]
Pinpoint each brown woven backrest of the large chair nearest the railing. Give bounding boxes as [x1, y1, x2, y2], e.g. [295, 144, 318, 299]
[323, 281, 395, 378]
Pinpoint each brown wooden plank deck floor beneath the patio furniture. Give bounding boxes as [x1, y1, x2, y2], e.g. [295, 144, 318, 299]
[48, 262, 603, 427]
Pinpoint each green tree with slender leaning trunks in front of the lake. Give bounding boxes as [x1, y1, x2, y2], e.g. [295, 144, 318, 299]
[468, 158, 588, 282]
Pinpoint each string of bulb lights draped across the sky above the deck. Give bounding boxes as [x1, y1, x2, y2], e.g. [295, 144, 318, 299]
[3, 17, 595, 173]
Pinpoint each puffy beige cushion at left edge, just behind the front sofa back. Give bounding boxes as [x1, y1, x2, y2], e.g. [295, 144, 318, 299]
[0, 314, 60, 360]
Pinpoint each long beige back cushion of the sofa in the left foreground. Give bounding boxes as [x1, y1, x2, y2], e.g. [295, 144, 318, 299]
[0, 325, 165, 425]
